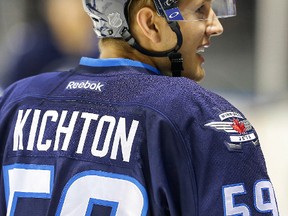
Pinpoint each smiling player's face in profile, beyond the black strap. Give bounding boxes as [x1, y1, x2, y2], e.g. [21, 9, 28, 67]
[179, 0, 223, 81]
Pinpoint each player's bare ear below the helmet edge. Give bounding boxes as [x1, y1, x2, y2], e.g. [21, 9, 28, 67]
[136, 7, 161, 43]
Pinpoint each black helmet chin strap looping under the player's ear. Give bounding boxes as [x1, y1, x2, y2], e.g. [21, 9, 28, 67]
[121, 21, 184, 77]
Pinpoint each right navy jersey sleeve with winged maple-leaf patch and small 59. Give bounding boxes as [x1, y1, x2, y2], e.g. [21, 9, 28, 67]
[182, 99, 279, 215]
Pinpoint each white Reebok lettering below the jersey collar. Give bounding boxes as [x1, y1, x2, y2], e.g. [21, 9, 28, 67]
[66, 80, 104, 92]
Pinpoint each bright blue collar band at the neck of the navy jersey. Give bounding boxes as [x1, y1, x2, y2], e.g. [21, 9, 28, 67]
[80, 57, 161, 75]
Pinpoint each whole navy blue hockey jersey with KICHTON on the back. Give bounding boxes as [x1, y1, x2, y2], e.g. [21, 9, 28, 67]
[0, 58, 279, 216]
